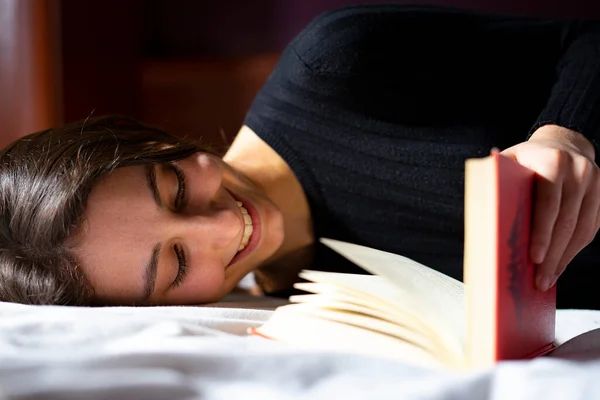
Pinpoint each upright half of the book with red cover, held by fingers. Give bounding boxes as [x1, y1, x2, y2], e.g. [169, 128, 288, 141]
[464, 152, 556, 367]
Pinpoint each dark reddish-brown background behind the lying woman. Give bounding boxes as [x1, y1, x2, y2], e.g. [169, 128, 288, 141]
[0, 0, 600, 150]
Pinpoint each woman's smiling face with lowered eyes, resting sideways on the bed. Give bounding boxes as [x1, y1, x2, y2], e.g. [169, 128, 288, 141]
[73, 153, 283, 304]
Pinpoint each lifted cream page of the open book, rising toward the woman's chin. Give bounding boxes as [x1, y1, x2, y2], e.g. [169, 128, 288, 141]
[321, 239, 466, 355]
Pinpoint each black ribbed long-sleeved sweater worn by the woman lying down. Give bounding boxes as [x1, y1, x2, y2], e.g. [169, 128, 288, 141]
[245, 5, 600, 306]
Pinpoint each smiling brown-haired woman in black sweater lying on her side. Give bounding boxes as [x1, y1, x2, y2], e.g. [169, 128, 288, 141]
[0, 5, 600, 308]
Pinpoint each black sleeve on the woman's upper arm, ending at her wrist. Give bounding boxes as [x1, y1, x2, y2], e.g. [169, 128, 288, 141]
[244, 4, 600, 148]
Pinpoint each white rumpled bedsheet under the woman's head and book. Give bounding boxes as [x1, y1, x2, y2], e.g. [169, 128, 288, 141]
[0, 303, 600, 400]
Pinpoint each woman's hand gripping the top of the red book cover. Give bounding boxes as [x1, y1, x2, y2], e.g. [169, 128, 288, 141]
[502, 125, 600, 291]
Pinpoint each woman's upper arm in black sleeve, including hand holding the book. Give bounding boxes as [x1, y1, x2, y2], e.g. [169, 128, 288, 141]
[293, 5, 600, 290]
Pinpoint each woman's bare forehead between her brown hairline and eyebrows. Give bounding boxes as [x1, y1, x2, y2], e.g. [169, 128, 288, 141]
[74, 166, 157, 301]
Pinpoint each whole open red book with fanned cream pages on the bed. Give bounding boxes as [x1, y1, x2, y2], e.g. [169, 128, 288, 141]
[253, 152, 556, 369]
